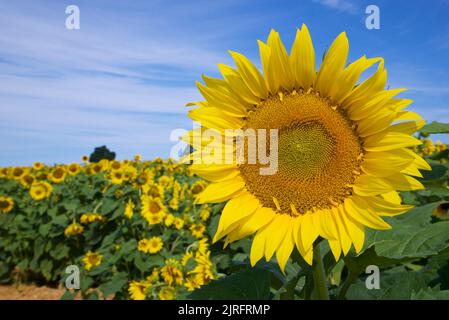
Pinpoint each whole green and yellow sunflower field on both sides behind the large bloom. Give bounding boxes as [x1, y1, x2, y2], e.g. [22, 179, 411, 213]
[0, 131, 449, 299]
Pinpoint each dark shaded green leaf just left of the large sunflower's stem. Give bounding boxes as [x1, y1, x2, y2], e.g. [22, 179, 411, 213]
[189, 268, 270, 300]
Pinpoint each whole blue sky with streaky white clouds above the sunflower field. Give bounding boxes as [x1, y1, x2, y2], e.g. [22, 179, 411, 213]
[0, 0, 449, 166]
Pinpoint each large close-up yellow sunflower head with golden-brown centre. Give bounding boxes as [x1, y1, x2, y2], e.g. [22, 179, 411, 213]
[183, 25, 430, 270]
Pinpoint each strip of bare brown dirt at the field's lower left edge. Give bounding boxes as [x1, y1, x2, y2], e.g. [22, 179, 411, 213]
[0, 284, 65, 300]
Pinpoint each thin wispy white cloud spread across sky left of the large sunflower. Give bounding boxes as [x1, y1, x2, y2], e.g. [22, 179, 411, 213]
[0, 1, 262, 165]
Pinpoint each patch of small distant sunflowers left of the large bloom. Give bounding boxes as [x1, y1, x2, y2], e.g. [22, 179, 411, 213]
[0, 156, 224, 299]
